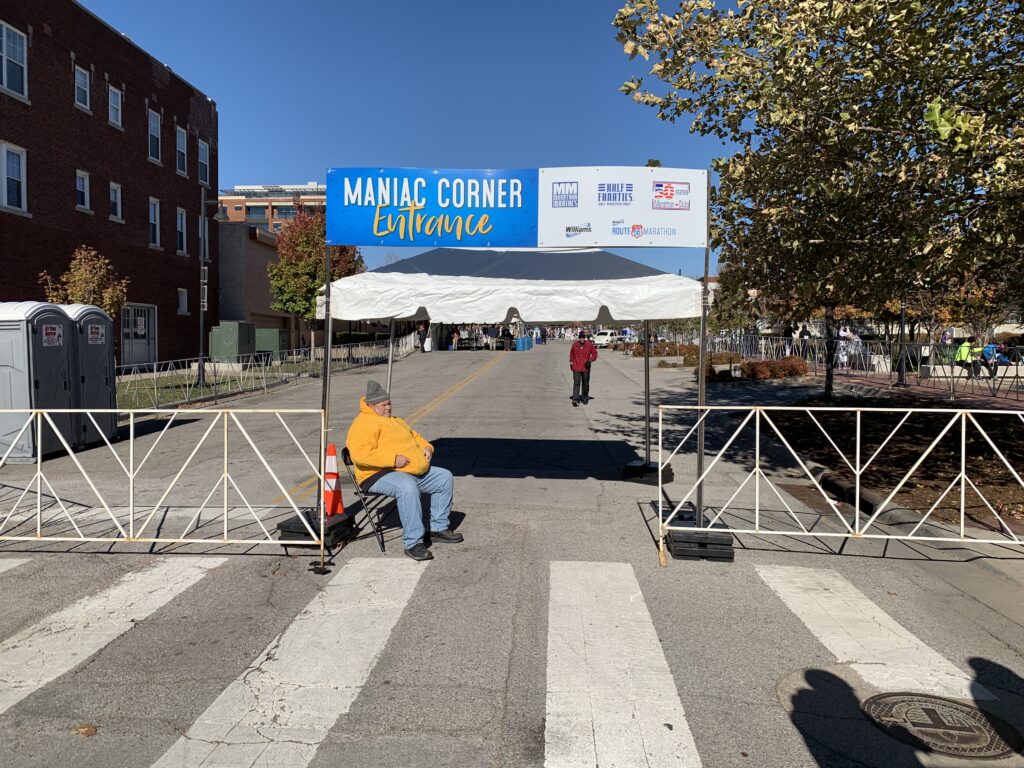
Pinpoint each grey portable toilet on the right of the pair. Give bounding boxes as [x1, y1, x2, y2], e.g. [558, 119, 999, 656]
[61, 304, 118, 445]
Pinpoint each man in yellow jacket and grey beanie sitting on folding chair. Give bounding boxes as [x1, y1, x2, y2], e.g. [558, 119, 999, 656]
[345, 381, 463, 560]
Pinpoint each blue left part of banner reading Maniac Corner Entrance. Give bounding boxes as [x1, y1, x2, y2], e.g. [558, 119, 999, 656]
[327, 168, 538, 248]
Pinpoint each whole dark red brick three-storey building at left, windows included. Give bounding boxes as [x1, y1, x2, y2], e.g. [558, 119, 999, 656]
[0, 0, 218, 364]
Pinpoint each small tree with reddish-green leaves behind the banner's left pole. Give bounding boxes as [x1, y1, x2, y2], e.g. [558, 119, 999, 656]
[267, 205, 366, 338]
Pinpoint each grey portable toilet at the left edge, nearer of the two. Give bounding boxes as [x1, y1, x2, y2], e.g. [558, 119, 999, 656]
[0, 301, 78, 461]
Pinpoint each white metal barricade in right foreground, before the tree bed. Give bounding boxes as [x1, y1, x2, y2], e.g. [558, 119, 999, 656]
[657, 406, 1024, 553]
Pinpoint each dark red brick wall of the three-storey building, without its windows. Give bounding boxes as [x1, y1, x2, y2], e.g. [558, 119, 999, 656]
[0, 0, 217, 359]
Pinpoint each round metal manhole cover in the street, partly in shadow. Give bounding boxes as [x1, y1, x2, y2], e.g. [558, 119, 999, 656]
[862, 693, 1022, 760]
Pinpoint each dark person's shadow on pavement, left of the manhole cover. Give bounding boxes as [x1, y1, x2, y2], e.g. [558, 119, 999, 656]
[790, 670, 931, 768]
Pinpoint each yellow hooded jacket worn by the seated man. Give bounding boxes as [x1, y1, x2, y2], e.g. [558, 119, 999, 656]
[345, 397, 434, 485]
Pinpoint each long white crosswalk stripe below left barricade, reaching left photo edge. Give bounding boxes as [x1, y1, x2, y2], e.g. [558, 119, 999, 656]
[0, 557, 224, 713]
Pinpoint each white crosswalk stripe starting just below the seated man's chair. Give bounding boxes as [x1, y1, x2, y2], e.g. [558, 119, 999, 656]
[149, 558, 425, 768]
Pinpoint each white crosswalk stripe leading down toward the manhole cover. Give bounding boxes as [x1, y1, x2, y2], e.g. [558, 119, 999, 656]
[756, 565, 993, 699]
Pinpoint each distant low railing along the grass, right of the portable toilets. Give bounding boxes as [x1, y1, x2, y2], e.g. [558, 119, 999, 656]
[117, 334, 416, 411]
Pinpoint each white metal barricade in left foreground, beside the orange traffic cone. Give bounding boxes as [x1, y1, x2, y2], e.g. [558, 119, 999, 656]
[0, 409, 327, 549]
